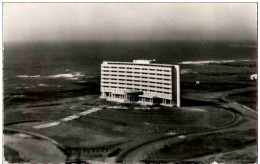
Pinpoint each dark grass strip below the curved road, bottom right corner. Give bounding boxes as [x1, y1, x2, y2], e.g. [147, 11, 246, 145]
[145, 129, 257, 163]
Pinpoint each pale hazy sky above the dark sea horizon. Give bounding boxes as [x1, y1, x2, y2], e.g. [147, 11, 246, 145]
[3, 3, 257, 42]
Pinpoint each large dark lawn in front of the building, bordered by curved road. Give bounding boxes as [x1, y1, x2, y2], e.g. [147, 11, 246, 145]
[6, 101, 234, 155]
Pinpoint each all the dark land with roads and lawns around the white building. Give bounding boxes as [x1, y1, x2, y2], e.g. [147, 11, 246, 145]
[4, 60, 257, 163]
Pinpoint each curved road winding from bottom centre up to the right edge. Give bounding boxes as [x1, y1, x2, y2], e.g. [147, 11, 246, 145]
[116, 88, 257, 163]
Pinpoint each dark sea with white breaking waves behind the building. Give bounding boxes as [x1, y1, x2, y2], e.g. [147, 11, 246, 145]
[3, 41, 257, 110]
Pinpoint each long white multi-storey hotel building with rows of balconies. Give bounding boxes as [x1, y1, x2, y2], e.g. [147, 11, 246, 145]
[101, 60, 181, 107]
